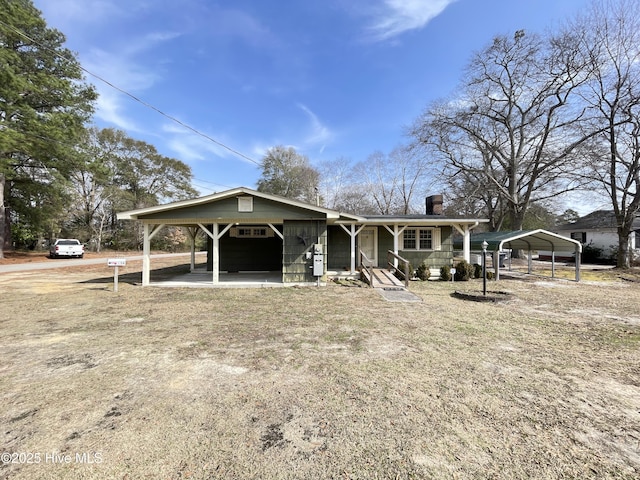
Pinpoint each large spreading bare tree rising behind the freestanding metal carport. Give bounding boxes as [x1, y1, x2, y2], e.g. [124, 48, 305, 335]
[411, 31, 591, 229]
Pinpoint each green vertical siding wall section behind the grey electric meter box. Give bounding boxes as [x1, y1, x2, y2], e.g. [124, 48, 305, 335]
[282, 220, 327, 283]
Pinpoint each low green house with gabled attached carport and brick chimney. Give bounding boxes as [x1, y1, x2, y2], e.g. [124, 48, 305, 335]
[118, 187, 488, 285]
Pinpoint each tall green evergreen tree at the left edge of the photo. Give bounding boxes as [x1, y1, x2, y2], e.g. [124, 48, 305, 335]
[0, 0, 96, 258]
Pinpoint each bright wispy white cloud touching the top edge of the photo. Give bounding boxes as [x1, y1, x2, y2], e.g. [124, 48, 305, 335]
[369, 0, 457, 41]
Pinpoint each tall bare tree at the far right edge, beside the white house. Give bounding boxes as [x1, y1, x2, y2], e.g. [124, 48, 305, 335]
[570, 0, 640, 268]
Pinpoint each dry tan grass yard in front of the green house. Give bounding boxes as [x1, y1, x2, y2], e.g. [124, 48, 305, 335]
[0, 259, 640, 479]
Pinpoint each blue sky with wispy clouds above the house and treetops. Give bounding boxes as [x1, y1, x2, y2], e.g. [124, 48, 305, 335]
[34, 0, 589, 194]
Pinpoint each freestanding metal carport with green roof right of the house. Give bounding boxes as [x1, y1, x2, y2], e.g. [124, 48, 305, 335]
[471, 229, 582, 282]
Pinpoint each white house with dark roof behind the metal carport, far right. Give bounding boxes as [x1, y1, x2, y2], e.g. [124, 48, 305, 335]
[540, 210, 640, 258]
